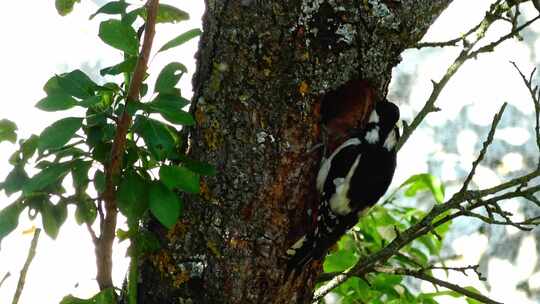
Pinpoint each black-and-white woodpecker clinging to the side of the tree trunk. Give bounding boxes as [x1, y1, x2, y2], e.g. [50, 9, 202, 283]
[287, 100, 399, 273]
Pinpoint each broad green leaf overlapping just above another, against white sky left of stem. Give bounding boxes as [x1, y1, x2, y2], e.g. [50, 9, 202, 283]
[57, 70, 98, 99]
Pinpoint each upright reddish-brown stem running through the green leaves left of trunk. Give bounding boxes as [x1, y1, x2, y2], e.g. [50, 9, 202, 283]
[96, 0, 159, 290]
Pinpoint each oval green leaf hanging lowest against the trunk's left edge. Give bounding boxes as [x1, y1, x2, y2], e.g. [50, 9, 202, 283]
[148, 182, 182, 229]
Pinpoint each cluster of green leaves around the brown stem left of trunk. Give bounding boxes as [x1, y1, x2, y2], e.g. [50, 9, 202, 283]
[0, 1, 202, 253]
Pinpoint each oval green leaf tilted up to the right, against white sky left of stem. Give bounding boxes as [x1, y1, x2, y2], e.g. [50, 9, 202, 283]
[38, 117, 83, 151]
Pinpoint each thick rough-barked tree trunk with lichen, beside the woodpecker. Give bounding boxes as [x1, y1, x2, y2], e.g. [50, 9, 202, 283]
[139, 0, 451, 304]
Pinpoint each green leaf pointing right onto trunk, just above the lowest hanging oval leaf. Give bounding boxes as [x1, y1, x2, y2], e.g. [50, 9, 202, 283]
[159, 166, 201, 193]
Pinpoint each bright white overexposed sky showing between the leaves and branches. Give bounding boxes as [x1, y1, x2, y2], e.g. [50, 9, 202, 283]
[0, 0, 540, 304]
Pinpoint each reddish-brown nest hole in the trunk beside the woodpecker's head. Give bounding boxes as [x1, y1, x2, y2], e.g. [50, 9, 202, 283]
[321, 80, 375, 153]
